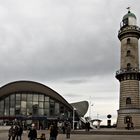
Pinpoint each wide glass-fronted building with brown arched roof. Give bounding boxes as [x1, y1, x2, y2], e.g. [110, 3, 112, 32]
[0, 81, 87, 129]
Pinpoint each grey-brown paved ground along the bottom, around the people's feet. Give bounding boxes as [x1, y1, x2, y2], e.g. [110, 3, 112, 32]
[0, 131, 140, 140]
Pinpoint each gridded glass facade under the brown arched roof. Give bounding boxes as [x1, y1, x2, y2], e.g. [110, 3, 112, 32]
[0, 92, 72, 118]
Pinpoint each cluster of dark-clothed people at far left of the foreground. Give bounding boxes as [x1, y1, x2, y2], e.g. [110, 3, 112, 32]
[8, 124, 23, 140]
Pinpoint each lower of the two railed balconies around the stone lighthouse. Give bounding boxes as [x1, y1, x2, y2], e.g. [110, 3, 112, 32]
[116, 68, 140, 81]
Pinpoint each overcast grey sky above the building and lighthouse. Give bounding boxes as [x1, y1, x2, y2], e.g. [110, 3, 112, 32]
[0, 0, 140, 123]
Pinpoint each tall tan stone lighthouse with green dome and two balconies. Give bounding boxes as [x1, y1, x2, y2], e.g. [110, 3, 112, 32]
[116, 8, 140, 128]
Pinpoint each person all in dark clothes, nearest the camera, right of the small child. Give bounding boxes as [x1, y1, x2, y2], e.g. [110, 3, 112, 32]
[49, 124, 58, 140]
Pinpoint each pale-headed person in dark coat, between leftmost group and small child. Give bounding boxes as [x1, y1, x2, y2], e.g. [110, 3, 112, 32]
[28, 124, 37, 140]
